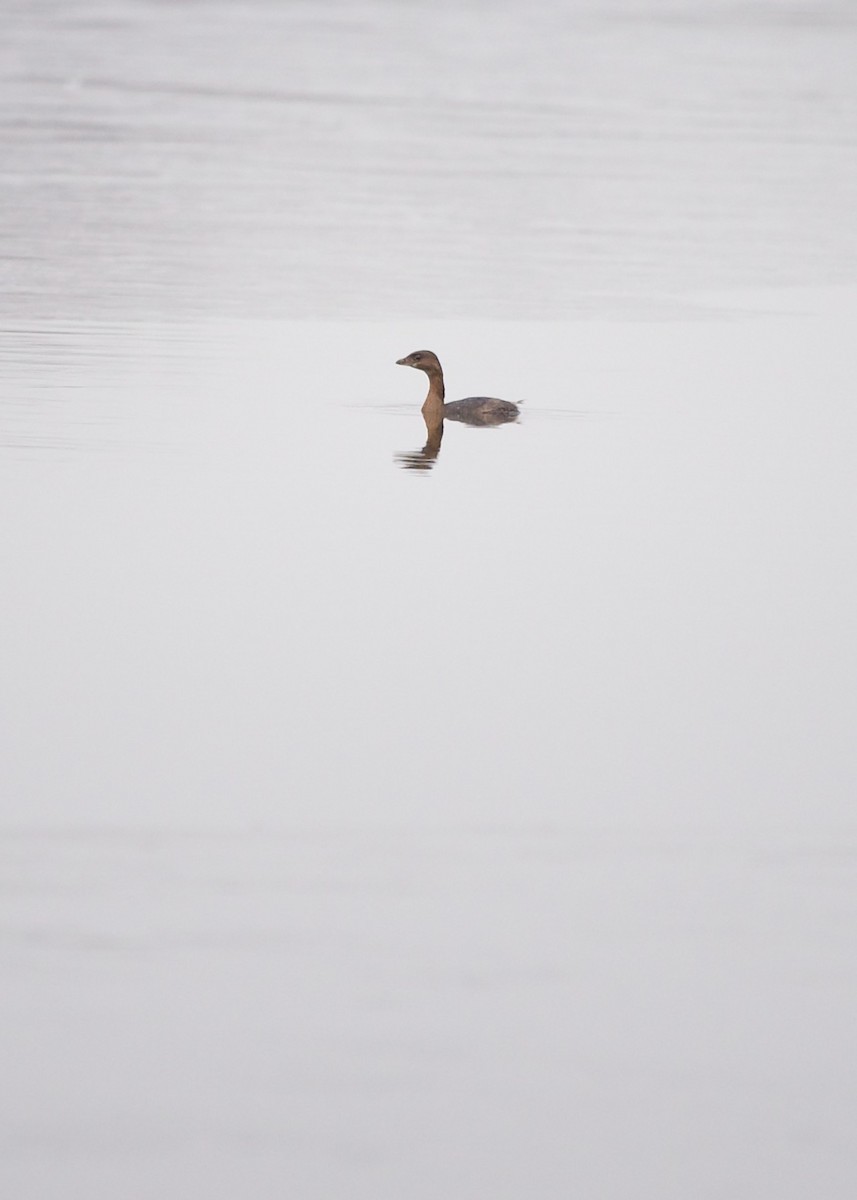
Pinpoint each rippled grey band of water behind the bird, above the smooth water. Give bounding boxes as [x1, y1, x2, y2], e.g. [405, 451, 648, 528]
[0, 0, 857, 321]
